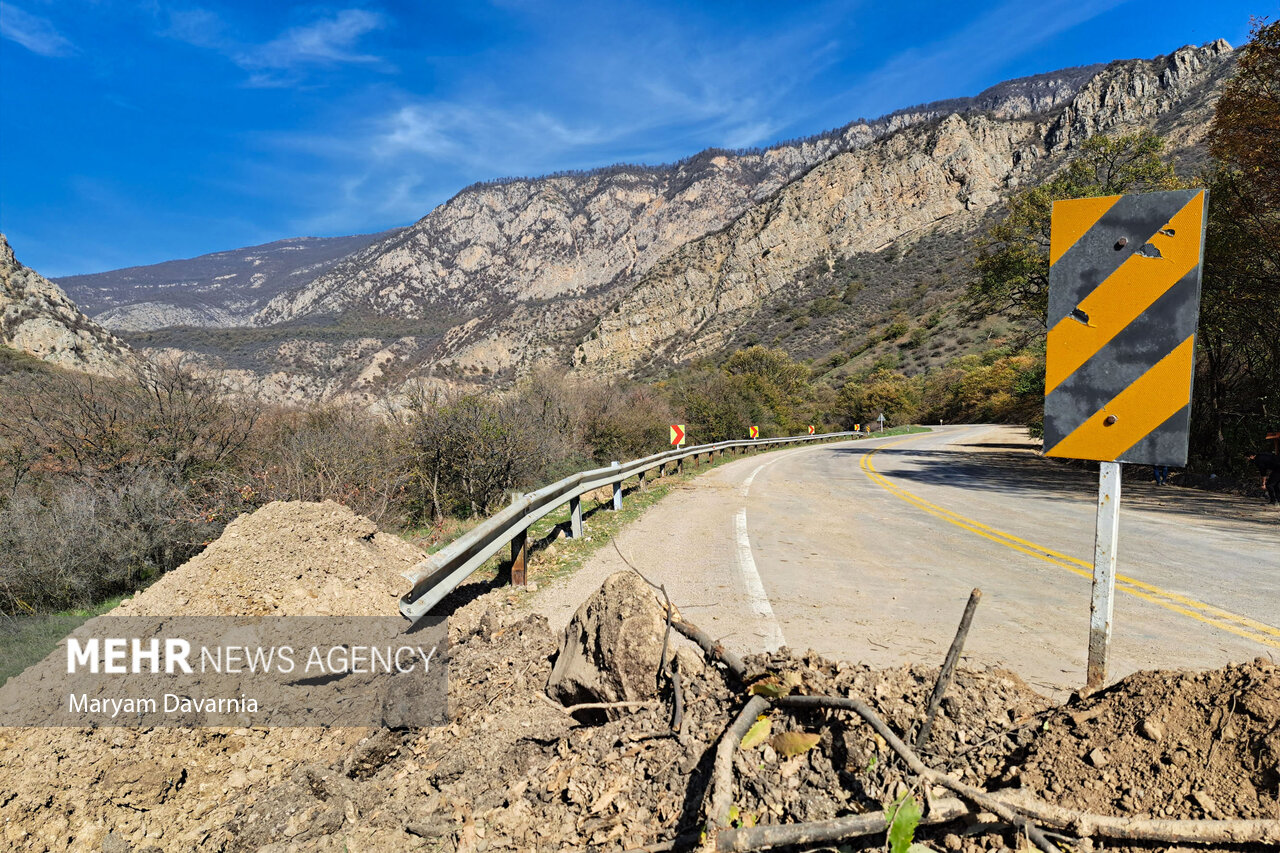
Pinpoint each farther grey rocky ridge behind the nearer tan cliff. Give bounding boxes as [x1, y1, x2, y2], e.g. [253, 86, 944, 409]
[256, 60, 1121, 325]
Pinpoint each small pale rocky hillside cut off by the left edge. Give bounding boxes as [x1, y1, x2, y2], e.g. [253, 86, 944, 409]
[0, 234, 136, 375]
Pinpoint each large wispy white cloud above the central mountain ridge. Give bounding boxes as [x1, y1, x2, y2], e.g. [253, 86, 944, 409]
[246, 9, 855, 233]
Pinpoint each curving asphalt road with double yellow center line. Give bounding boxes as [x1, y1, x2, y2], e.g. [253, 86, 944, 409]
[534, 427, 1280, 694]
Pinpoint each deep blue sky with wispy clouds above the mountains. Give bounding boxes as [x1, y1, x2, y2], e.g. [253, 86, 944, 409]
[0, 0, 1259, 277]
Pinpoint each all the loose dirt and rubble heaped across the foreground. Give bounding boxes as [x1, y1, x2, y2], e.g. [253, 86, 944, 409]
[0, 505, 1280, 852]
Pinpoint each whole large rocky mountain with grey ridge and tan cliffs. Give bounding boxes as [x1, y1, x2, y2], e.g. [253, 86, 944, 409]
[115, 41, 1234, 396]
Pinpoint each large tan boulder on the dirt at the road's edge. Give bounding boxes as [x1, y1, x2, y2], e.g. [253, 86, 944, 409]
[547, 571, 666, 706]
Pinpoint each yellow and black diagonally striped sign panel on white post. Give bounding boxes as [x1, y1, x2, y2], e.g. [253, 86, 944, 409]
[1044, 190, 1207, 465]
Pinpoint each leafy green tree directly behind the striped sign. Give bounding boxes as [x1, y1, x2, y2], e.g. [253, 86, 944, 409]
[966, 131, 1179, 325]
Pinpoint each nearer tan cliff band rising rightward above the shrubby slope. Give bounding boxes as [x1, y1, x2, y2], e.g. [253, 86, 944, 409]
[573, 41, 1230, 373]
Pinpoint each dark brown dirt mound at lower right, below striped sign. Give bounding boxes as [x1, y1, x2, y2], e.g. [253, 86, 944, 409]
[1014, 658, 1280, 820]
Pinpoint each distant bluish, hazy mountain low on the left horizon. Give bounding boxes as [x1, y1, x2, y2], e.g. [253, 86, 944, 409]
[56, 232, 396, 332]
